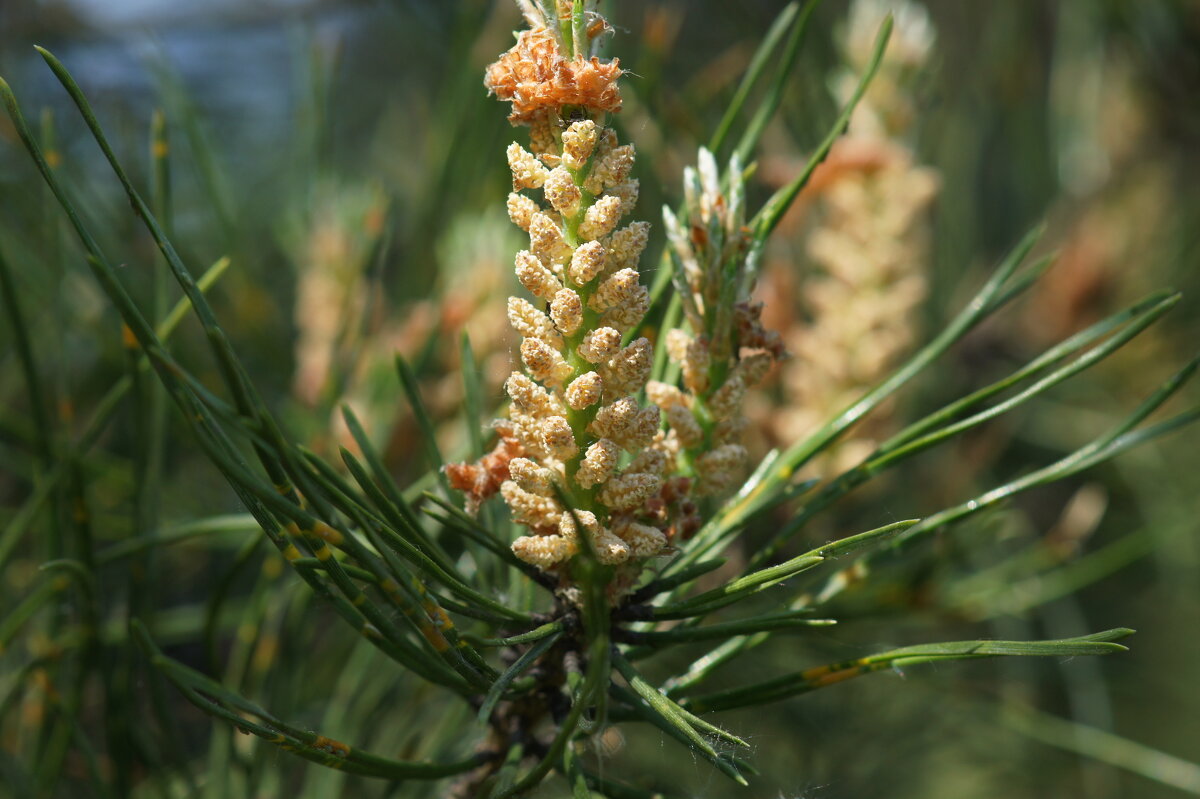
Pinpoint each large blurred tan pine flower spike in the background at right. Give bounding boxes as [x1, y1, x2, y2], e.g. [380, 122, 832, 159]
[763, 0, 940, 474]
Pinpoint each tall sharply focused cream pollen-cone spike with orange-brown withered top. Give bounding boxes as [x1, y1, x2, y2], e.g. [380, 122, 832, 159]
[452, 4, 676, 585]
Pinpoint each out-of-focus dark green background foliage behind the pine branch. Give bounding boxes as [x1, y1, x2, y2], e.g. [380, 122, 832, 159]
[0, 0, 1200, 799]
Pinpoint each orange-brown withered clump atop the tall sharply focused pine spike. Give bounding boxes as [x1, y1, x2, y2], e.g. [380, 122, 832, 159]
[484, 28, 622, 125]
